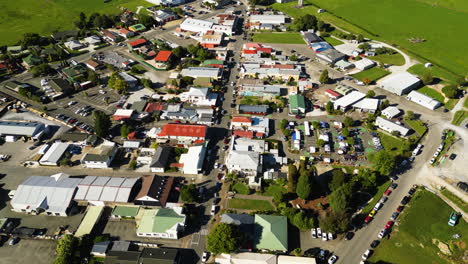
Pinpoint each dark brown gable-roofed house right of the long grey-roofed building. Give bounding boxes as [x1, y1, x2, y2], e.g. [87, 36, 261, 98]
[134, 175, 174, 207]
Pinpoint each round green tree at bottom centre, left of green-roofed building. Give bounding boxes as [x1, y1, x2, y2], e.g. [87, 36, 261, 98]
[206, 223, 244, 254]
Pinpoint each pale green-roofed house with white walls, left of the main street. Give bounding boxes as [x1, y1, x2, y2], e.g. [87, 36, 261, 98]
[137, 207, 186, 239]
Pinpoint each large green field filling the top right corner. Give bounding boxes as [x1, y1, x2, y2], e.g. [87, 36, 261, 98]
[273, 0, 468, 75]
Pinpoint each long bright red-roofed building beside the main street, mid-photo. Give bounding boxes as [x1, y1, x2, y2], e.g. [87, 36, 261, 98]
[158, 124, 207, 144]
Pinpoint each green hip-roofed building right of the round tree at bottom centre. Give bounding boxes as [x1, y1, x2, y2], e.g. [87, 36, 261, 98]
[254, 214, 288, 251]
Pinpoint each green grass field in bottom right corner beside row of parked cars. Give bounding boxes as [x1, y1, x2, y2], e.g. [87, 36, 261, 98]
[370, 190, 468, 264]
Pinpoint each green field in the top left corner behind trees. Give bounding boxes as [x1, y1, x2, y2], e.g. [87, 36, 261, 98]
[0, 0, 152, 45]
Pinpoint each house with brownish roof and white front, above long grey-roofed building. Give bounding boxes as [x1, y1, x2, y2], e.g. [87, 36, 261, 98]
[81, 141, 118, 169]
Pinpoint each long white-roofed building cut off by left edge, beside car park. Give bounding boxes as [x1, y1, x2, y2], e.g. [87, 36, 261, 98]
[0, 121, 46, 142]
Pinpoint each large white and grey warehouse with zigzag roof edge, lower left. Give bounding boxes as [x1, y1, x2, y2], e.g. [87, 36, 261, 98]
[10, 173, 81, 216]
